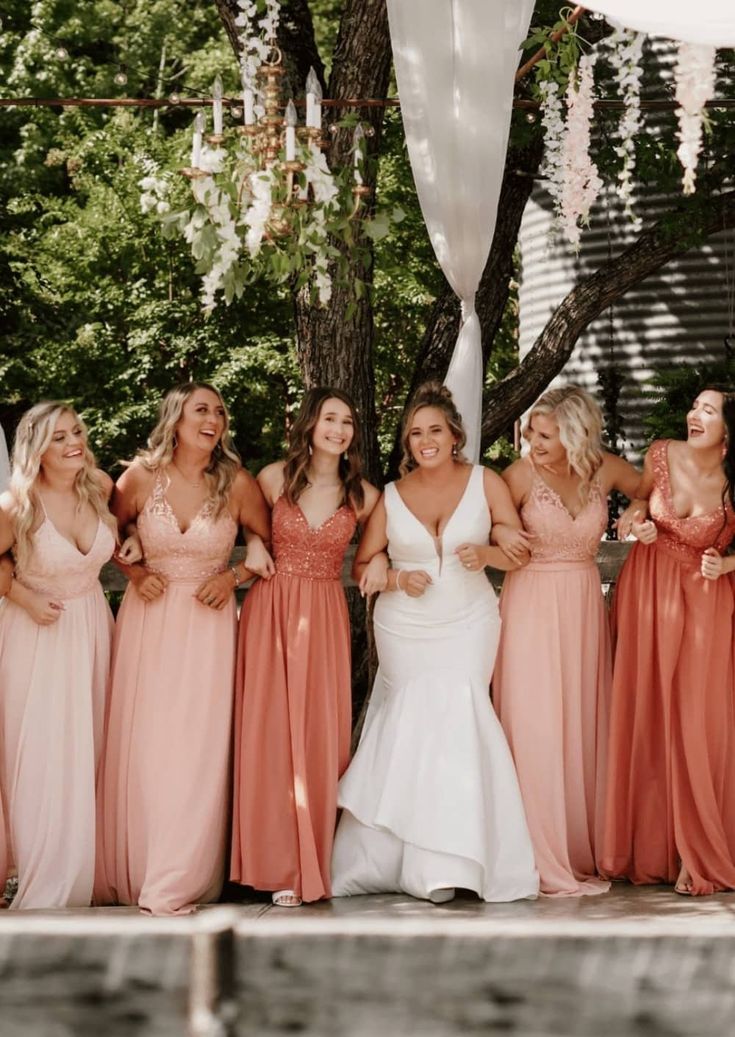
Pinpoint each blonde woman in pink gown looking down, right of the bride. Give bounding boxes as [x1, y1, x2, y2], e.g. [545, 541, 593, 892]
[492, 386, 641, 896]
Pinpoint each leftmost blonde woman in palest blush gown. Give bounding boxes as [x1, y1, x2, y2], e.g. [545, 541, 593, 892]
[0, 402, 131, 907]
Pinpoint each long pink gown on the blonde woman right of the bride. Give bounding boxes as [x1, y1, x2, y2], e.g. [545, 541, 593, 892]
[492, 458, 612, 896]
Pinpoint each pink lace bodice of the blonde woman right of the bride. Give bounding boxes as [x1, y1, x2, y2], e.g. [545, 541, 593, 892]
[520, 459, 607, 562]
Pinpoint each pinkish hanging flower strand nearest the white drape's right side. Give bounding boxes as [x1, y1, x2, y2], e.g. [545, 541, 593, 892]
[561, 51, 602, 250]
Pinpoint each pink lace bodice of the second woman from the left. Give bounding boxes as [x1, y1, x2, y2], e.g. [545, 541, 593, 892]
[138, 472, 237, 582]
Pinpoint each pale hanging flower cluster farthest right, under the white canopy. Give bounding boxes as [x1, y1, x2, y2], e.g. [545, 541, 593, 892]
[674, 44, 716, 194]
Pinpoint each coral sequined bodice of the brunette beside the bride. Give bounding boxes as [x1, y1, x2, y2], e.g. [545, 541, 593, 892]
[273, 497, 358, 580]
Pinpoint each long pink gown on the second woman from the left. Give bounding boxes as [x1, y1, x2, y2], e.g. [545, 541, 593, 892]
[94, 473, 236, 915]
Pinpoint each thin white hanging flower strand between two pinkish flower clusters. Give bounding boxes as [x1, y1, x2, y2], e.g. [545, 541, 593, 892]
[606, 27, 645, 230]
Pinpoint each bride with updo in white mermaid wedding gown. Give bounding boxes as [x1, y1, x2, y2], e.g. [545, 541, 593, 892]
[332, 383, 538, 903]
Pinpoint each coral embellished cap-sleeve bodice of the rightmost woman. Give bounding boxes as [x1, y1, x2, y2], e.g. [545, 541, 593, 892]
[649, 440, 735, 564]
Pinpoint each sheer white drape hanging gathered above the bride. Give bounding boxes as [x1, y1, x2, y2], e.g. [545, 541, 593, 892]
[388, 0, 534, 461]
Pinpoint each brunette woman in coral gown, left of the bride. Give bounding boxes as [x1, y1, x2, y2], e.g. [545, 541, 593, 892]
[230, 388, 378, 907]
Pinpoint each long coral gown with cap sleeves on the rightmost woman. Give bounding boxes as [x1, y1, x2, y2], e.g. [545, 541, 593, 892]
[599, 441, 735, 894]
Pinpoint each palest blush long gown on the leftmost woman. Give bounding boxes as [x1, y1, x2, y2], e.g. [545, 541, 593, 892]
[0, 516, 115, 908]
